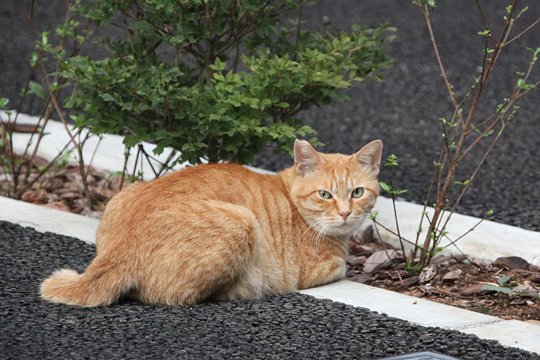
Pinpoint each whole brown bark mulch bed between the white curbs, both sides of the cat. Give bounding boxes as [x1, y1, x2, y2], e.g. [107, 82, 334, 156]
[0, 159, 540, 323]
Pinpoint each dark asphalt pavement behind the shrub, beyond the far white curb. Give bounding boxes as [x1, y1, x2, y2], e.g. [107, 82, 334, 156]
[0, 0, 540, 231]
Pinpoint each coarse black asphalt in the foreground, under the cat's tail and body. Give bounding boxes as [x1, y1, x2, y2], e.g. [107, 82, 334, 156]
[0, 221, 540, 360]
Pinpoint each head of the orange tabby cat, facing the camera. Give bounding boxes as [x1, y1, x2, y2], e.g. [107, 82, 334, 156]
[291, 140, 383, 237]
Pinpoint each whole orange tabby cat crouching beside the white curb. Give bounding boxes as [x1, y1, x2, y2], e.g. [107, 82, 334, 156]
[41, 140, 382, 306]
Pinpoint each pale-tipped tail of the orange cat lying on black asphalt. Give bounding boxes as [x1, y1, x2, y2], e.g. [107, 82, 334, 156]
[40, 256, 133, 307]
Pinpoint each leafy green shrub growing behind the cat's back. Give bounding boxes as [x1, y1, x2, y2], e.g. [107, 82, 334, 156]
[57, 0, 389, 163]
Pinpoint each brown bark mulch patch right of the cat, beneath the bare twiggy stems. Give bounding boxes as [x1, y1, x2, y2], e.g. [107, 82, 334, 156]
[347, 228, 540, 323]
